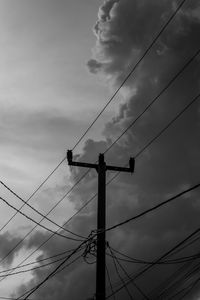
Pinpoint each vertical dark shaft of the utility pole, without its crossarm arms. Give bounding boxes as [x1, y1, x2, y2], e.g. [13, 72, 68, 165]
[96, 156, 106, 300]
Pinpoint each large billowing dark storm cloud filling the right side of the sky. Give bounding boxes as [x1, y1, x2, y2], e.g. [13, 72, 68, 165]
[15, 0, 200, 300]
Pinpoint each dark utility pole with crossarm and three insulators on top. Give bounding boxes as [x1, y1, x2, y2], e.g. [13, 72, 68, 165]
[67, 150, 135, 300]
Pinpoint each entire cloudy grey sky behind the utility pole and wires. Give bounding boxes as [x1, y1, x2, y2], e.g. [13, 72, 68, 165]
[0, 0, 200, 300]
